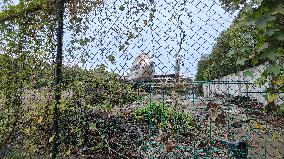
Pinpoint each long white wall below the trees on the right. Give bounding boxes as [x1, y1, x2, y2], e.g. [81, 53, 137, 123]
[203, 63, 284, 104]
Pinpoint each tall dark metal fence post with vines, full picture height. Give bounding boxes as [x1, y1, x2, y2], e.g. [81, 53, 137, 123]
[51, 0, 64, 159]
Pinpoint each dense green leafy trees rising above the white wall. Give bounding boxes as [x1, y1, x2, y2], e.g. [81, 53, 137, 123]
[196, 0, 284, 110]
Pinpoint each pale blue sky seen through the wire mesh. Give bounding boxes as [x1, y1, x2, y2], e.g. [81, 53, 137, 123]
[0, 0, 239, 77]
